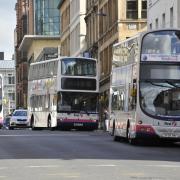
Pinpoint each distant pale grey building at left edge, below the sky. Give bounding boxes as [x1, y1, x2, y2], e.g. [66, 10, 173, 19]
[0, 59, 16, 117]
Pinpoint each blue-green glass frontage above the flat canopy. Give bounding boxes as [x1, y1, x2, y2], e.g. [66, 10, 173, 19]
[35, 0, 60, 35]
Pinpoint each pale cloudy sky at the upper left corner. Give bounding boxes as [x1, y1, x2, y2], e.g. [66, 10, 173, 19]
[0, 0, 17, 60]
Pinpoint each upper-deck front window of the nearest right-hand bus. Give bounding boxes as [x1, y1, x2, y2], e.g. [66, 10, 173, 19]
[141, 30, 180, 62]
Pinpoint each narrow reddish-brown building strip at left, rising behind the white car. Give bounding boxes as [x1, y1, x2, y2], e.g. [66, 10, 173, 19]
[15, 0, 28, 107]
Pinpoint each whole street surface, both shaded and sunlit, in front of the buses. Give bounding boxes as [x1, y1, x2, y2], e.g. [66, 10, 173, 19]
[0, 130, 180, 180]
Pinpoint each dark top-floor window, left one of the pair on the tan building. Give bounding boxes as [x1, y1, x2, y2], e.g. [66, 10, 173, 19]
[126, 0, 138, 19]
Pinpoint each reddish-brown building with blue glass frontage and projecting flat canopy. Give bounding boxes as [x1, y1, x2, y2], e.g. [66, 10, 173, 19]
[15, 0, 60, 108]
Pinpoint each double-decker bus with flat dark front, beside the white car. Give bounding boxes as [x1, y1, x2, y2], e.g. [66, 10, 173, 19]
[28, 57, 99, 130]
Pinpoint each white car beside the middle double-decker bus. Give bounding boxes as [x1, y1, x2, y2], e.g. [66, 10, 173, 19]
[9, 109, 29, 129]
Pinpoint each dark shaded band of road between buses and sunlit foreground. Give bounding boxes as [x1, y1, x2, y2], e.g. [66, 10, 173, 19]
[0, 130, 180, 162]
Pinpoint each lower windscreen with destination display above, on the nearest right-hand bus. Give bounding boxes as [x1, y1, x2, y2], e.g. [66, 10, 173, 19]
[140, 64, 180, 116]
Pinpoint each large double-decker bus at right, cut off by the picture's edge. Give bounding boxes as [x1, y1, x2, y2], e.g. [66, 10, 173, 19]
[109, 29, 180, 144]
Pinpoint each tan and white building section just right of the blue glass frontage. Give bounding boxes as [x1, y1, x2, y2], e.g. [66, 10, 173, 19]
[58, 0, 86, 56]
